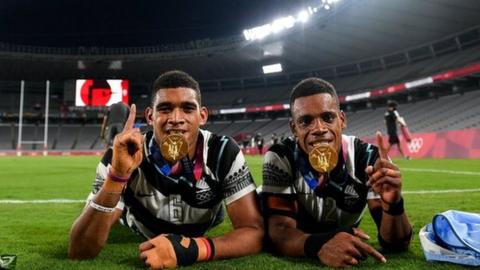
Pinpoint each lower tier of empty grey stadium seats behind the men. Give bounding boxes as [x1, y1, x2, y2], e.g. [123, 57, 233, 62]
[0, 89, 480, 150]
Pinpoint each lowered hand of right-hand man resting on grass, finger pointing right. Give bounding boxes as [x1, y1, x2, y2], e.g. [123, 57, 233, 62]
[318, 228, 387, 267]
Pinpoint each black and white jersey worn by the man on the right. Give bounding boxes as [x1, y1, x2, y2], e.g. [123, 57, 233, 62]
[261, 135, 379, 233]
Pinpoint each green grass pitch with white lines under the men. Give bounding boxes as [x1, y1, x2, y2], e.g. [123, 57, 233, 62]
[0, 156, 480, 270]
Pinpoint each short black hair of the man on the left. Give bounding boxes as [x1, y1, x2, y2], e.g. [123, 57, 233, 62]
[152, 70, 202, 105]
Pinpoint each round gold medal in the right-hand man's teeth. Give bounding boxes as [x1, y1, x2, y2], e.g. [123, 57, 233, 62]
[308, 144, 338, 173]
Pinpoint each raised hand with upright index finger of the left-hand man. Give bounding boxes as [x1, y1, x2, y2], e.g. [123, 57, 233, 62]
[111, 104, 143, 177]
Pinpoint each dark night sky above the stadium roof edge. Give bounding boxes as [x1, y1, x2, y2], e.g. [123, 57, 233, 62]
[0, 0, 306, 47]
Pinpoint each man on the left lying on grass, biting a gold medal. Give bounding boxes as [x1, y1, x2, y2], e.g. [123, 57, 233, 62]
[69, 71, 264, 269]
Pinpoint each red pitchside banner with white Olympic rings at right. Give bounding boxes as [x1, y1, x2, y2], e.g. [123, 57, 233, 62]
[364, 128, 480, 158]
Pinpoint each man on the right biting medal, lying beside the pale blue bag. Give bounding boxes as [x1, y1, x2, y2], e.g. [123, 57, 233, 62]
[261, 78, 412, 267]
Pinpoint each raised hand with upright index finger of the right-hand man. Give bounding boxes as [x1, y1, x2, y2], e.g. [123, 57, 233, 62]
[365, 131, 402, 204]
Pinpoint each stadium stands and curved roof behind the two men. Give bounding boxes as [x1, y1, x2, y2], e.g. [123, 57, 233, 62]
[0, 0, 480, 158]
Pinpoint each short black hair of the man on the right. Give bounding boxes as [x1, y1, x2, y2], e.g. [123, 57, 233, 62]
[290, 77, 340, 113]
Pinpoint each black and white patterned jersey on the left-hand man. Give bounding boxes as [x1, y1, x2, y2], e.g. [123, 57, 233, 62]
[89, 130, 255, 238]
